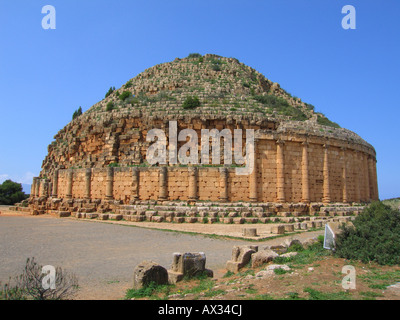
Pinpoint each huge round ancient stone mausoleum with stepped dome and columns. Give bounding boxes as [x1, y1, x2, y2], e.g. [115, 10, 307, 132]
[29, 55, 378, 221]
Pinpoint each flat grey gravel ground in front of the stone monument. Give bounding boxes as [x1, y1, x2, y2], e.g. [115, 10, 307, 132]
[0, 211, 322, 299]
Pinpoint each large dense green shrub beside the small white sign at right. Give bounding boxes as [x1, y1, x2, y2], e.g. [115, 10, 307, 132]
[335, 202, 400, 265]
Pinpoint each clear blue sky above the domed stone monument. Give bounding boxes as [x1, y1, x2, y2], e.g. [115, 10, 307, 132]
[0, 0, 400, 199]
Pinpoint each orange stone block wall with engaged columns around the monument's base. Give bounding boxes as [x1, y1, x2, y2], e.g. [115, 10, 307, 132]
[32, 133, 378, 204]
